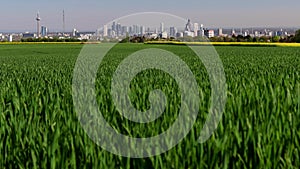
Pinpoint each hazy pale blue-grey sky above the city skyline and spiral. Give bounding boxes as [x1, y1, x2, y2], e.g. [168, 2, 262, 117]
[0, 0, 300, 32]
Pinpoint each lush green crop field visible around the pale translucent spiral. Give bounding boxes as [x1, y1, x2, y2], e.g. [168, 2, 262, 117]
[0, 44, 300, 169]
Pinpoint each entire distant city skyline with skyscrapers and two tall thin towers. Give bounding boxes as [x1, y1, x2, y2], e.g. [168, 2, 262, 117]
[0, 11, 295, 42]
